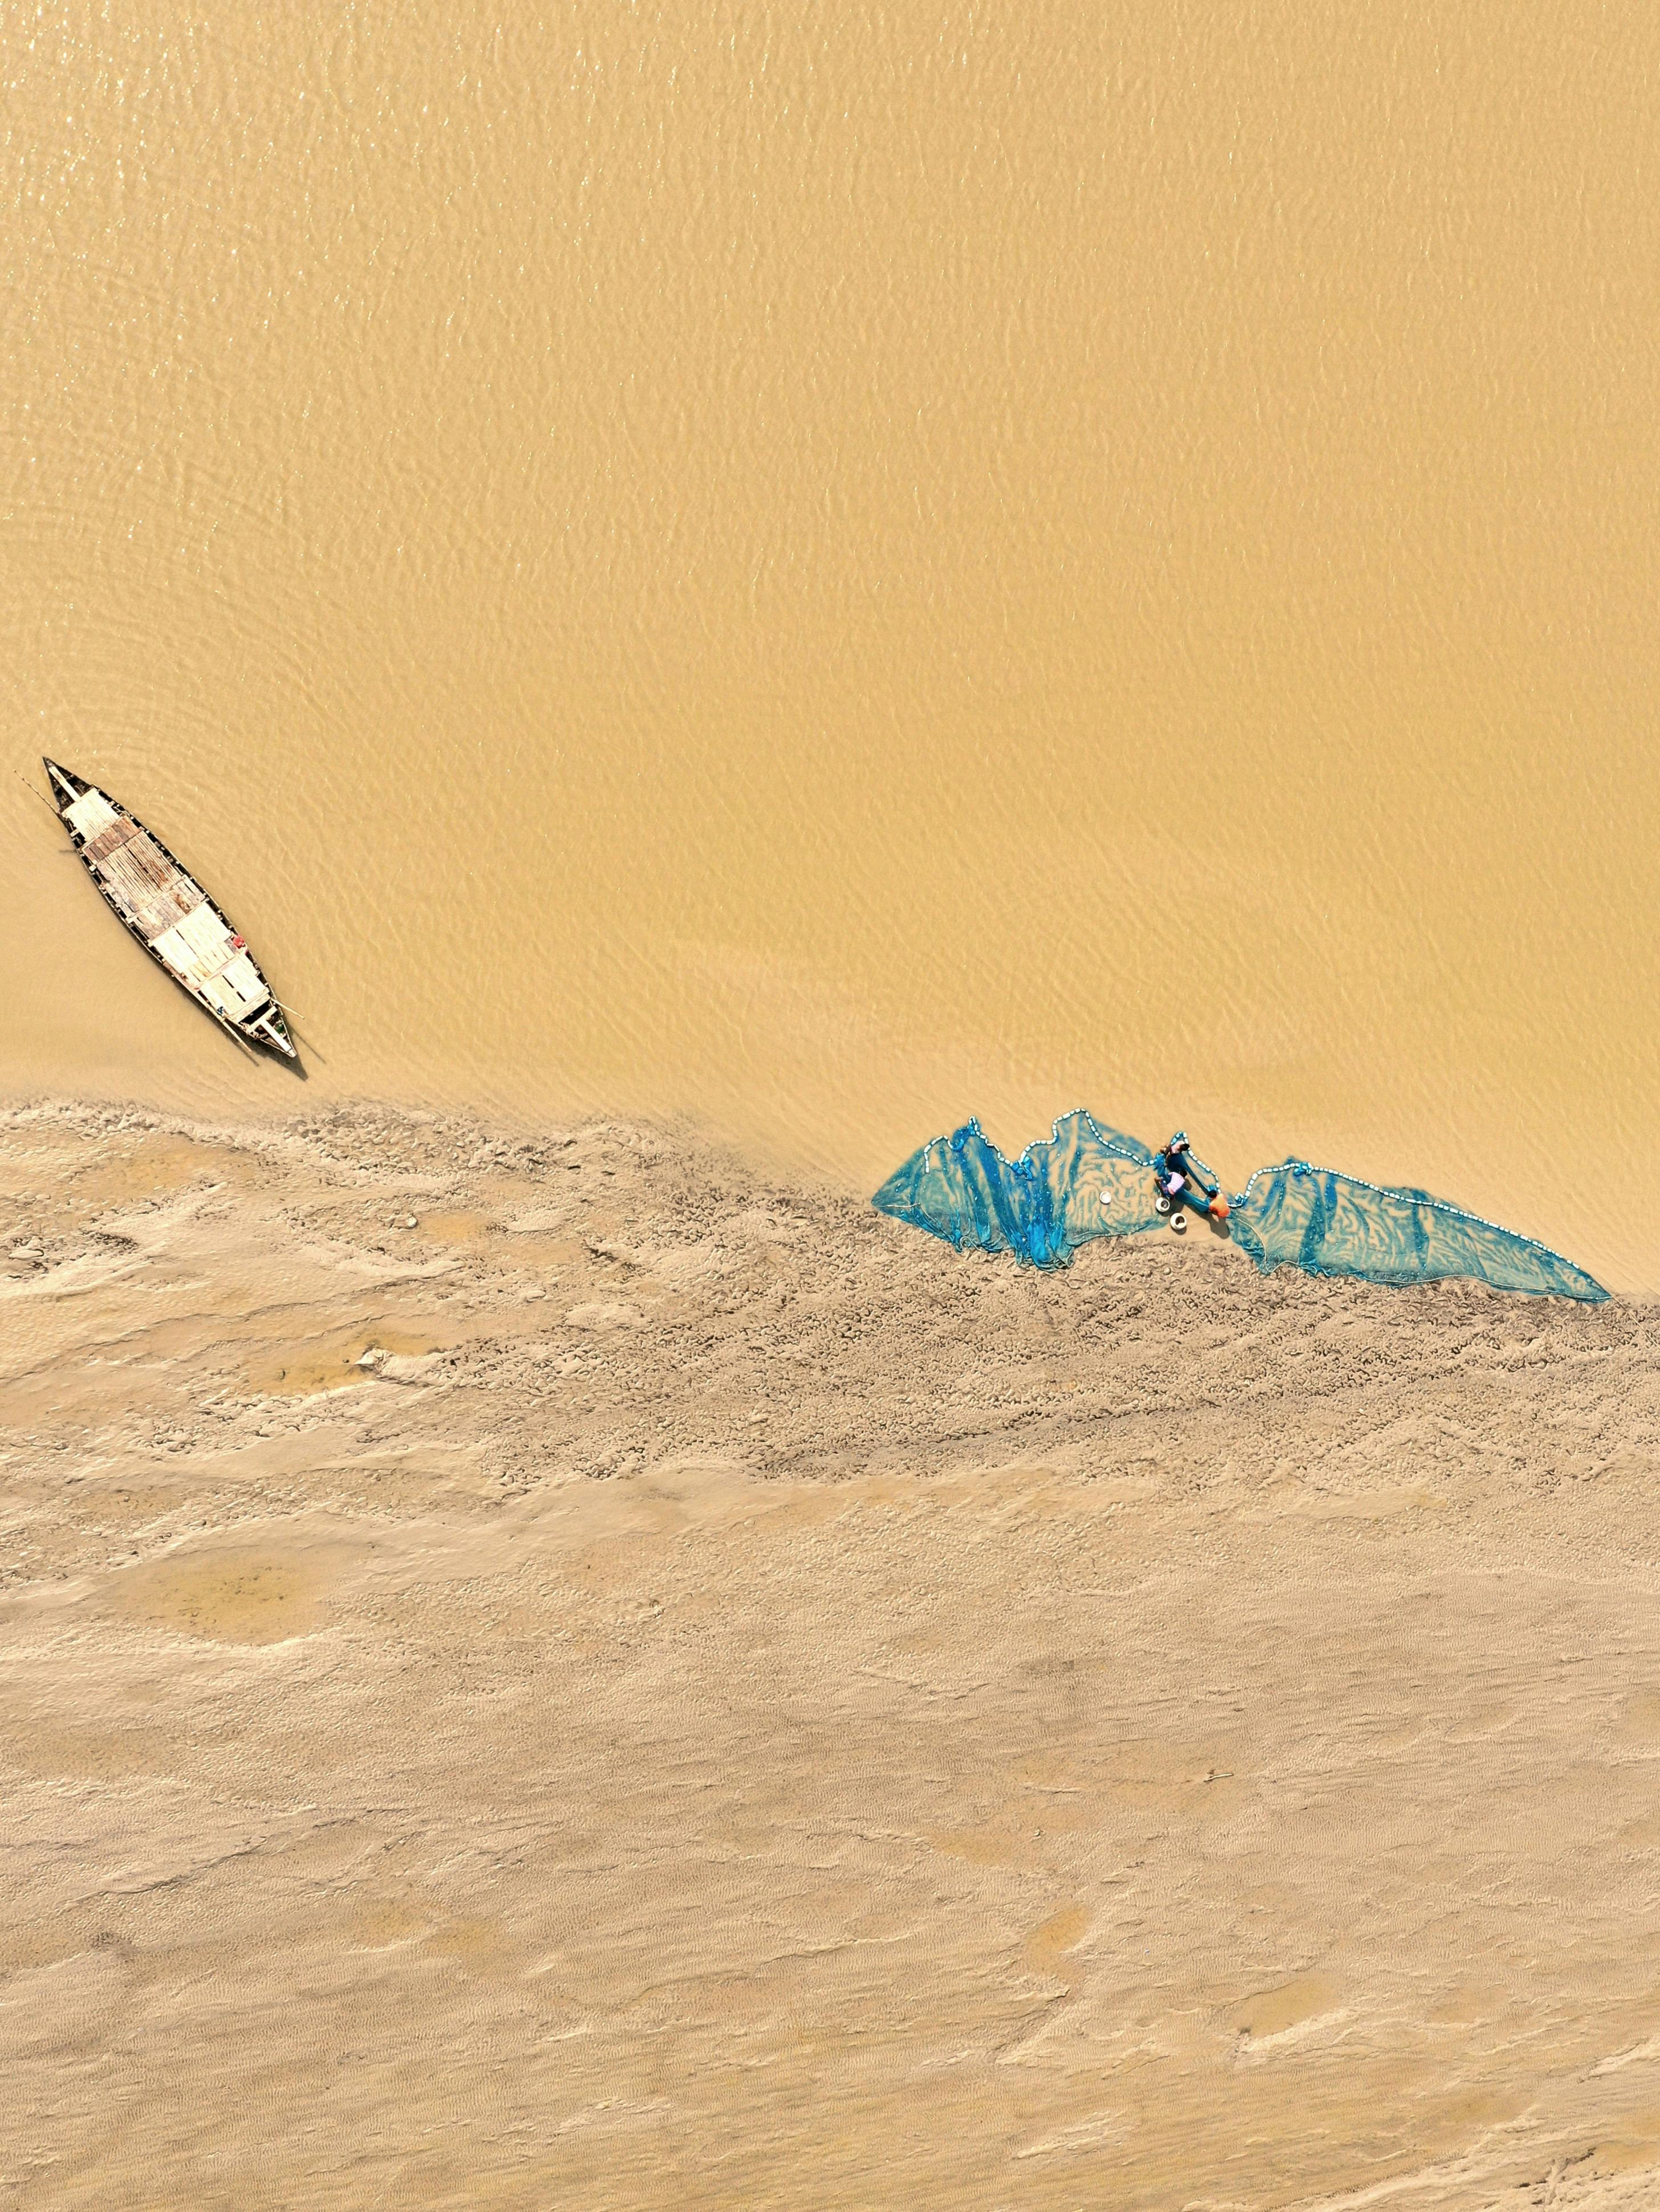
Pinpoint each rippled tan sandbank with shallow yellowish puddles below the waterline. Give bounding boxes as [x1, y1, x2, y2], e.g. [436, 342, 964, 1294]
[0, 1104, 1660, 2212]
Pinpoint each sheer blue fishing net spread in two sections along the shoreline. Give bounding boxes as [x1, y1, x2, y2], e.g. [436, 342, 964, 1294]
[872, 1108, 1607, 1299]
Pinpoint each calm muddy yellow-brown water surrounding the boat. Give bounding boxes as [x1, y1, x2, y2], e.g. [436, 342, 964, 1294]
[0, 0, 1660, 1292]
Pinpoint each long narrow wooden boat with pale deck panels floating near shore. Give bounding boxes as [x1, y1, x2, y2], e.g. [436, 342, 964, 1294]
[42, 761, 299, 1060]
